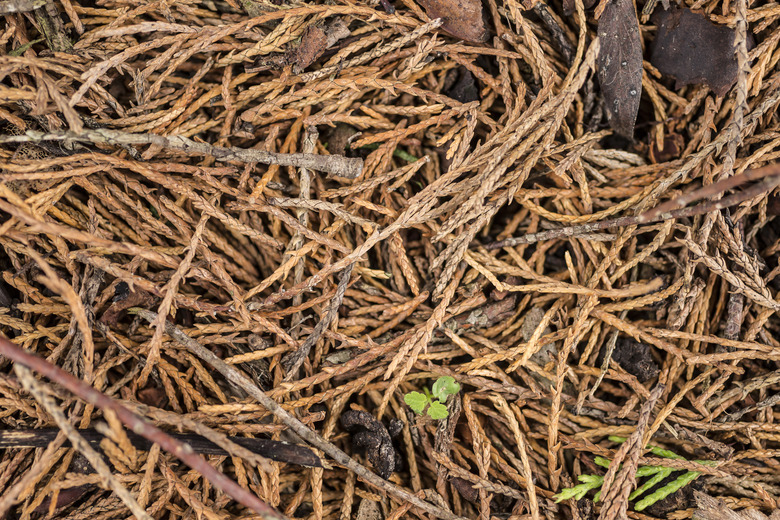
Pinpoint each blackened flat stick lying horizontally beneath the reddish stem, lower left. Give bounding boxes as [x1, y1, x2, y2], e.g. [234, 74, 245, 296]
[0, 428, 322, 468]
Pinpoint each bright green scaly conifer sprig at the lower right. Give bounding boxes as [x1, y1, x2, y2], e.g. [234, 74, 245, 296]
[553, 436, 715, 511]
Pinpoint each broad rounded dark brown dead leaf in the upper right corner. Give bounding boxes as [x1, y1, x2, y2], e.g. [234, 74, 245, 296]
[650, 6, 750, 96]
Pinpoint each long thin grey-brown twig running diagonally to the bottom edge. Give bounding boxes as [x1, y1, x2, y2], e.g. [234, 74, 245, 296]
[128, 308, 465, 520]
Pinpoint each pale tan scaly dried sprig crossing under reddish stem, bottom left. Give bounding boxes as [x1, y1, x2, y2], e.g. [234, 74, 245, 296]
[12, 364, 153, 520]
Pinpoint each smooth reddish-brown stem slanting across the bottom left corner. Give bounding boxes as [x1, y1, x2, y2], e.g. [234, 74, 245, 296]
[0, 338, 287, 520]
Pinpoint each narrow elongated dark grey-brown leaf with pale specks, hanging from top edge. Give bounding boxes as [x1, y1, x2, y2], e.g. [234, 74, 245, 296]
[598, 0, 642, 139]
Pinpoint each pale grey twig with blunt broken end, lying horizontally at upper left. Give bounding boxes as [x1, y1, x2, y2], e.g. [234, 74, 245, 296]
[0, 128, 363, 179]
